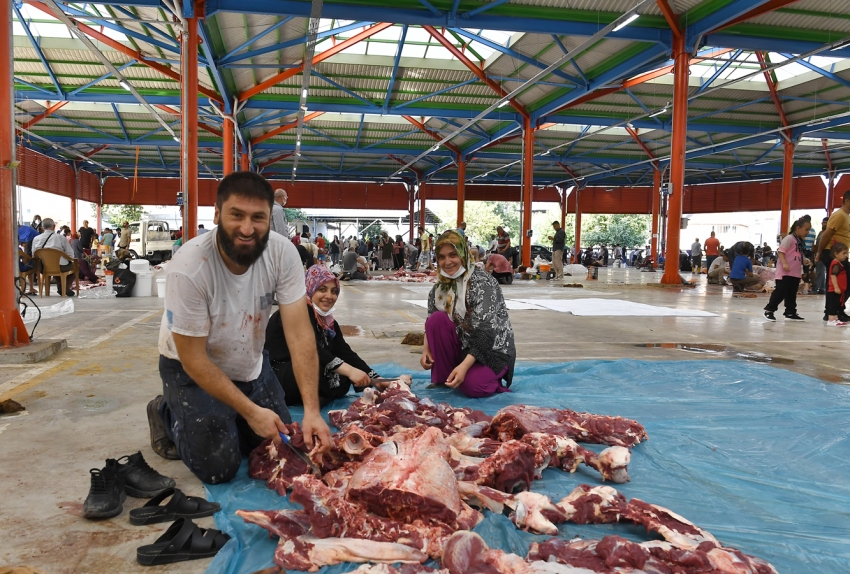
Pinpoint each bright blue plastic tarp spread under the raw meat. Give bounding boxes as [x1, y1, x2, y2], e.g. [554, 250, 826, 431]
[207, 360, 850, 574]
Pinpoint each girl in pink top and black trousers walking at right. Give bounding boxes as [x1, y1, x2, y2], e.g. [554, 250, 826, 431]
[764, 219, 812, 321]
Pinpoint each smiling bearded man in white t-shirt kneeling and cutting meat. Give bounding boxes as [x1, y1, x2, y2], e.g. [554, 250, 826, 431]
[147, 171, 332, 484]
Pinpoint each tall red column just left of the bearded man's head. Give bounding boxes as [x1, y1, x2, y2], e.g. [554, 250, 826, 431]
[180, 12, 198, 243]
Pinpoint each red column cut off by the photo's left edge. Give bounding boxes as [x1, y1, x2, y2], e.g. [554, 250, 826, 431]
[0, 0, 29, 348]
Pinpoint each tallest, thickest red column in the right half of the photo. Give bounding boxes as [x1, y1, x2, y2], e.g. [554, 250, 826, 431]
[661, 35, 691, 285]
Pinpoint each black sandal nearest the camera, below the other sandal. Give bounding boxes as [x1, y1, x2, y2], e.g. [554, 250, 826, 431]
[136, 518, 230, 566]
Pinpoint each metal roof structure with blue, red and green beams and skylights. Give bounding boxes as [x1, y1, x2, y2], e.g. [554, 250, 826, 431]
[9, 0, 850, 186]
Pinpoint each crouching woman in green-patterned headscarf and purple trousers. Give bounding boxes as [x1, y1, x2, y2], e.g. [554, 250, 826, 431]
[420, 230, 516, 397]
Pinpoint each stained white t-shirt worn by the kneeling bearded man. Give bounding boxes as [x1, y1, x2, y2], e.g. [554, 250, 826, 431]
[159, 232, 307, 381]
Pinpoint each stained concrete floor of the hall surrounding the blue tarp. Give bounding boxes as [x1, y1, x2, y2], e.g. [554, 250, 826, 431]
[0, 269, 850, 574]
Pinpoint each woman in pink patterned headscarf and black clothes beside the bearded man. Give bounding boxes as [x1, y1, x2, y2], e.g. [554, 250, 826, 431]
[265, 265, 378, 406]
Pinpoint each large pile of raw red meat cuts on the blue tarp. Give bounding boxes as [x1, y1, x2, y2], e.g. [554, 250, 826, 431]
[237, 377, 776, 574]
